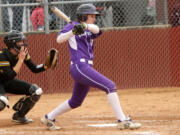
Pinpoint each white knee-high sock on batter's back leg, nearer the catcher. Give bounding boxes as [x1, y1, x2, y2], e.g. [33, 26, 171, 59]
[47, 100, 72, 120]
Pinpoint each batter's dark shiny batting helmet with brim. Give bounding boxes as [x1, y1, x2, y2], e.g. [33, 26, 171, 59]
[76, 4, 100, 22]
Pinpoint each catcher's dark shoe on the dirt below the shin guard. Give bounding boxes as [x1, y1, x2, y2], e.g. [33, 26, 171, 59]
[12, 113, 33, 124]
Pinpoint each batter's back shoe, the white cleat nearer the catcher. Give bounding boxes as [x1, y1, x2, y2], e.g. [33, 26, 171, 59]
[41, 115, 61, 130]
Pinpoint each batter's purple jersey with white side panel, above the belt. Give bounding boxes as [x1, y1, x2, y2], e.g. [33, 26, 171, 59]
[59, 22, 102, 61]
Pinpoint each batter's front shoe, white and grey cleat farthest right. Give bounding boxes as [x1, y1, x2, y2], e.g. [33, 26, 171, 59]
[117, 119, 142, 130]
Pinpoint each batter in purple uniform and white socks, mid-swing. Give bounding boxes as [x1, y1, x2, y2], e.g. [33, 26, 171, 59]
[41, 4, 141, 130]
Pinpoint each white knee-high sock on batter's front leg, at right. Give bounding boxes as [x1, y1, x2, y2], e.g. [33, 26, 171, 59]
[107, 92, 126, 121]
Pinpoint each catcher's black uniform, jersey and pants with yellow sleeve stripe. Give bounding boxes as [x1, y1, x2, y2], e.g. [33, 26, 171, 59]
[0, 49, 45, 95]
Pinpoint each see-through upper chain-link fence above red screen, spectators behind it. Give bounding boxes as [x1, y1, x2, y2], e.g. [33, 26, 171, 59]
[0, 0, 174, 33]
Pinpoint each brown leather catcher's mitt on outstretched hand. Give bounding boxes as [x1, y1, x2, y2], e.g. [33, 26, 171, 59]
[44, 48, 58, 69]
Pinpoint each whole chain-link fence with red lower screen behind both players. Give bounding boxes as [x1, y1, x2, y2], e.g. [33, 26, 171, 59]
[0, 0, 180, 93]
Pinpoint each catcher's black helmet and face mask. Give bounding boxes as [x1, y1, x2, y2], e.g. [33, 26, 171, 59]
[4, 30, 27, 52]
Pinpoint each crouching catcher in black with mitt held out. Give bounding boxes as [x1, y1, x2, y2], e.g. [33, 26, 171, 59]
[0, 30, 58, 124]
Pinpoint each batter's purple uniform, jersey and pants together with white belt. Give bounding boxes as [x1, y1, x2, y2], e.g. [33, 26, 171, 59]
[59, 22, 116, 108]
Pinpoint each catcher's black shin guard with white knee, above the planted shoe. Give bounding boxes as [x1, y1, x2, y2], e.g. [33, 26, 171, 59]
[13, 87, 42, 116]
